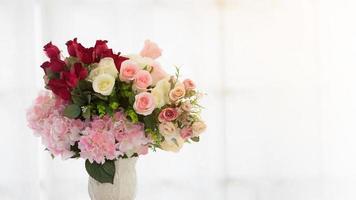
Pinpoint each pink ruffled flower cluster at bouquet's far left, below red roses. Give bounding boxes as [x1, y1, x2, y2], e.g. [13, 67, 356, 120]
[27, 92, 84, 159]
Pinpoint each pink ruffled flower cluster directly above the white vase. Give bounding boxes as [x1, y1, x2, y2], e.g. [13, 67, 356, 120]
[78, 111, 150, 163]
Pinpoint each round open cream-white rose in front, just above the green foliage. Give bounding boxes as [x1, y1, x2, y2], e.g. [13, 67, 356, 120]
[93, 74, 115, 96]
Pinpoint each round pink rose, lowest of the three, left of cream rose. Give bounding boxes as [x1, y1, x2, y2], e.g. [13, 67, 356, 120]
[133, 92, 156, 116]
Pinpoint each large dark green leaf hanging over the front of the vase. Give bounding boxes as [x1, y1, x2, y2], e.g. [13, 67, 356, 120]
[85, 160, 115, 184]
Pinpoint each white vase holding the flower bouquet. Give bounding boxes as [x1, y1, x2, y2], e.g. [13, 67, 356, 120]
[88, 157, 137, 200]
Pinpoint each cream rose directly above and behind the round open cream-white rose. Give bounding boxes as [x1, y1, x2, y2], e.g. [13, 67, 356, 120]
[87, 57, 119, 81]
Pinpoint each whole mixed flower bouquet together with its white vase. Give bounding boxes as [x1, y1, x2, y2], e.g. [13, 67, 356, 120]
[27, 38, 206, 200]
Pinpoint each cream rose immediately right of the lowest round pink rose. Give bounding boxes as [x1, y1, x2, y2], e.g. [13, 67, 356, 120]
[151, 77, 171, 108]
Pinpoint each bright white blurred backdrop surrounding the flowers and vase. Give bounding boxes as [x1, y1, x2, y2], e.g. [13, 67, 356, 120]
[0, 0, 356, 200]
